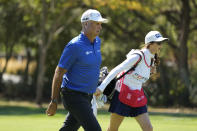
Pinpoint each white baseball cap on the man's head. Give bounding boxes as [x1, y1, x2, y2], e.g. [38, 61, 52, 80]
[81, 9, 108, 23]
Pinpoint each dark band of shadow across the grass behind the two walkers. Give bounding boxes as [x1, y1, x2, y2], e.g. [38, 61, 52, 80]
[0, 106, 197, 117]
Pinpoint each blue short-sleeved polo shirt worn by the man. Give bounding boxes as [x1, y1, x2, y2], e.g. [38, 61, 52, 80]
[58, 33, 101, 93]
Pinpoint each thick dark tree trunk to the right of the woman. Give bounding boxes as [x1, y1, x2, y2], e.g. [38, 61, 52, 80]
[175, 0, 192, 106]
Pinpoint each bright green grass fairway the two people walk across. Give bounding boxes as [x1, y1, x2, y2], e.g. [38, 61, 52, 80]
[0, 101, 197, 131]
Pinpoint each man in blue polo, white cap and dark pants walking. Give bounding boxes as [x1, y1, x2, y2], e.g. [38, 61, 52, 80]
[46, 9, 107, 131]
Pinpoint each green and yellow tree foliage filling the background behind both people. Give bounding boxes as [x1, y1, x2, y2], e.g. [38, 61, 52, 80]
[0, 0, 197, 106]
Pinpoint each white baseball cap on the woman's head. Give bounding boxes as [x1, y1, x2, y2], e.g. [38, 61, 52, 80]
[145, 31, 168, 44]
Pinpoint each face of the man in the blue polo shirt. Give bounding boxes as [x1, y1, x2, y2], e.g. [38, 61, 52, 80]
[86, 21, 102, 36]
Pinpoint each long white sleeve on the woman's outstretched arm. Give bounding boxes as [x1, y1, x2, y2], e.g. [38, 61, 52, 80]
[98, 54, 140, 92]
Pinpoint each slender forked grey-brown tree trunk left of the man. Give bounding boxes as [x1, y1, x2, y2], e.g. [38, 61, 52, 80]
[36, 0, 73, 105]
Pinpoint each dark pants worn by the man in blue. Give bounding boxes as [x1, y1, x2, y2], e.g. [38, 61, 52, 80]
[60, 88, 101, 131]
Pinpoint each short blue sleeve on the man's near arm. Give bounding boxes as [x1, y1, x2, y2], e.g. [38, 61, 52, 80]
[58, 44, 78, 70]
